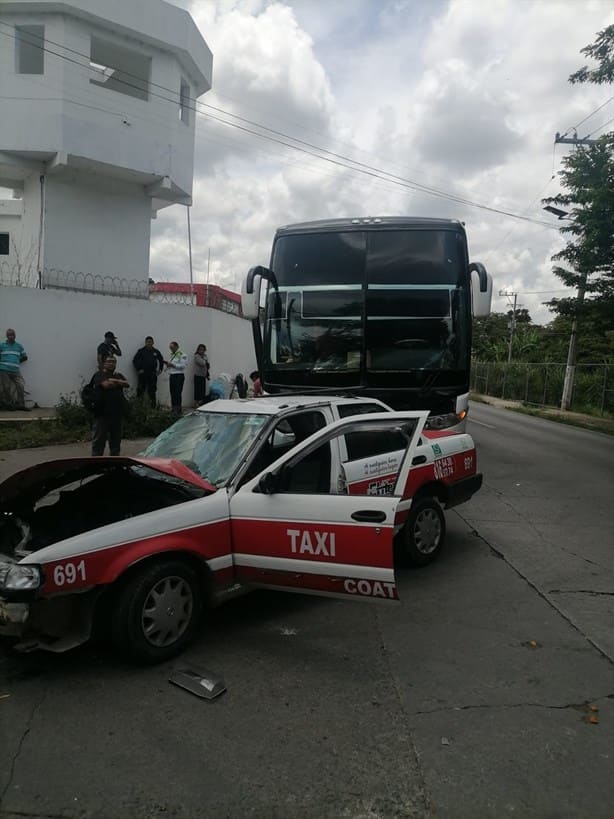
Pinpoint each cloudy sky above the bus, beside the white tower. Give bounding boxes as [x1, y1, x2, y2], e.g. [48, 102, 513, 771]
[151, 0, 614, 323]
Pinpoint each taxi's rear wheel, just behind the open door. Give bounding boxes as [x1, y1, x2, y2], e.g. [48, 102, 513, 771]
[397, 498, 446, 567]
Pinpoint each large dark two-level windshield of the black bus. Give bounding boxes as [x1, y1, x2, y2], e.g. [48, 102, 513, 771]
[264, 227, 470, 386]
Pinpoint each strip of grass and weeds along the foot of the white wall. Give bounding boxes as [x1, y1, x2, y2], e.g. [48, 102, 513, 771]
[0, 394, 177, 451]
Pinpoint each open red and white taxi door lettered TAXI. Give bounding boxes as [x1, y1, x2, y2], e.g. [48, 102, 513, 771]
[230, 412, 428, 601]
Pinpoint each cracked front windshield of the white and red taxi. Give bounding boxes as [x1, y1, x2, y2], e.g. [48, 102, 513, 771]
[142, 412, 269, 488]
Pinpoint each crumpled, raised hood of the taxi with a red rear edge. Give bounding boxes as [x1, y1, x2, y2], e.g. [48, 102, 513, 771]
[0, 456, 217, 510]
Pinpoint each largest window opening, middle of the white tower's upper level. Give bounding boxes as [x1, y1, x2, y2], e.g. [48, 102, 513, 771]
[90, 37, 151, 101]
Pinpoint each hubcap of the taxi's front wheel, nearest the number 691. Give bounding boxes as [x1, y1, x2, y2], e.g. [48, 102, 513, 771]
[141, 577, 194, 647]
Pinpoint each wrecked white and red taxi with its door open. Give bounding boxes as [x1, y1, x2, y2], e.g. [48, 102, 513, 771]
[0, 395, 482, 662]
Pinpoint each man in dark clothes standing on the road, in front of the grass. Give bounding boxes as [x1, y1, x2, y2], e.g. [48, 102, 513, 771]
[92, 355, 130, 455]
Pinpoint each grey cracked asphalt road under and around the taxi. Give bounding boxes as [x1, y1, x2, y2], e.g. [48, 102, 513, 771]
[0, 405, 614, 819]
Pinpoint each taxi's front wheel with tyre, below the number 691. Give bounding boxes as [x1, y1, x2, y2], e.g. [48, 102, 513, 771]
[111, 559, 204, 663]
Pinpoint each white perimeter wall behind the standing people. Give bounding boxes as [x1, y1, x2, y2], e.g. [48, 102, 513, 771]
[0, 286, 256, 407]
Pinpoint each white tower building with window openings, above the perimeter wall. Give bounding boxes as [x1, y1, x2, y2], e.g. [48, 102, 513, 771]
[0, 0, 212, 295]
